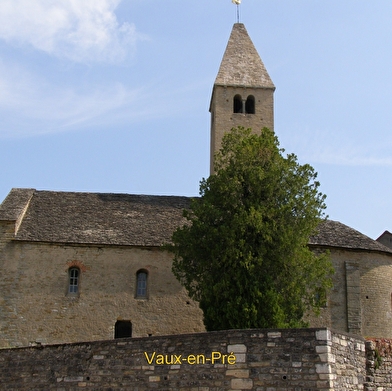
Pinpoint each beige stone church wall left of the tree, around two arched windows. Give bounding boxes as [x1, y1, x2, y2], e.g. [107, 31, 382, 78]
[0, 236, 205, 349]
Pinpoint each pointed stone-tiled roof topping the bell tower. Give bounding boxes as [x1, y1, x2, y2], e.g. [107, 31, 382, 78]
[215, 23, 275, 89]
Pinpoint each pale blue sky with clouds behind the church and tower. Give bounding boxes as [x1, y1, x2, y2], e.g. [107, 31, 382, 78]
[0, 0, 392, 238]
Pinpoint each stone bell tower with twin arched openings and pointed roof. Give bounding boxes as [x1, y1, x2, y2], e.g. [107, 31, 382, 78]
[210, 23, 275, 173]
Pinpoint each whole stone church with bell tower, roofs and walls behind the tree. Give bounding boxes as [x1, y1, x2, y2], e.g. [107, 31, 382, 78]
[0, 23, 392, 348]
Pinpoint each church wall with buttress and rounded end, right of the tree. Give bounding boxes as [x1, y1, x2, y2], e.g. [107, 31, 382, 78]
[307, 249, 392, 338]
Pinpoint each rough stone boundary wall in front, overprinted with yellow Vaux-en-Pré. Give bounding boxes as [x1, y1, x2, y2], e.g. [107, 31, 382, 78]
[0, 328, 366, 391]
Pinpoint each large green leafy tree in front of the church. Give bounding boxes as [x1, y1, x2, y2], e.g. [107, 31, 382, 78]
[168, 127, 333, 330]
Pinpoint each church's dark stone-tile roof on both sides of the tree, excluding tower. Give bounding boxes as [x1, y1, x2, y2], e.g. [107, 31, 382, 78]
[0, 189, 392, 253]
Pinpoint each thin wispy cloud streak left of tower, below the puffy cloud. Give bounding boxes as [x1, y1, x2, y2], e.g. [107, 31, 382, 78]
[0, 60, 198, 139]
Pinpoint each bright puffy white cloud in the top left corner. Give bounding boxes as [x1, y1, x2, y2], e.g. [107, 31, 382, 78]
[0, 0, 142, 62]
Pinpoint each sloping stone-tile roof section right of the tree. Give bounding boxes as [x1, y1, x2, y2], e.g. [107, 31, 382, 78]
[309, 220, 392, 254]
